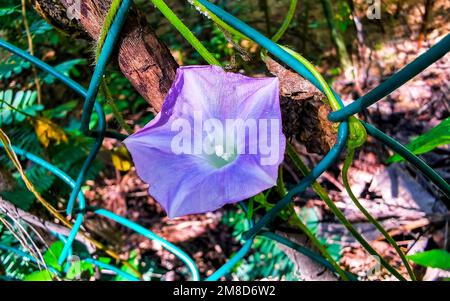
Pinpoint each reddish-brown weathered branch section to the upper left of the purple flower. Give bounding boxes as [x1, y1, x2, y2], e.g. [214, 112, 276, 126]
[34, 0, 178, 111]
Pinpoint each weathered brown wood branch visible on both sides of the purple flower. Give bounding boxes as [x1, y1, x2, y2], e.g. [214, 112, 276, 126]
[33, 0, 335, 154]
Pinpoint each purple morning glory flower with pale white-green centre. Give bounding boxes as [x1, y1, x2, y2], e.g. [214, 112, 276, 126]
[124, 66, 286, 218]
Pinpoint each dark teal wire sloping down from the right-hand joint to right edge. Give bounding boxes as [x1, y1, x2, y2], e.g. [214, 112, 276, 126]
[362, 122, 450, 198]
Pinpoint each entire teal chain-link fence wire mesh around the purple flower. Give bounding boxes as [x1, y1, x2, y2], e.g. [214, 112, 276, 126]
[0, 0, 450, 281]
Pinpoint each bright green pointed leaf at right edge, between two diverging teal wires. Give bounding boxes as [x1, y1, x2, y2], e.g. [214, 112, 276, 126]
[388, 117, 450, 163]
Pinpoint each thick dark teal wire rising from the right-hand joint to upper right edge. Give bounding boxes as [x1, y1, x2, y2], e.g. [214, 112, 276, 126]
[328, 34, 450, 122]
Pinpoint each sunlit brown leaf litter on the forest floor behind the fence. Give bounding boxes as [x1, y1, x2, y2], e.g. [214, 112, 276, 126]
[80, 1, 450, 280]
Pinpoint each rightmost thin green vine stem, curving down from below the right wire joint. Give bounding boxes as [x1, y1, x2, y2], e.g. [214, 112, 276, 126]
[342, 148, 417, 281]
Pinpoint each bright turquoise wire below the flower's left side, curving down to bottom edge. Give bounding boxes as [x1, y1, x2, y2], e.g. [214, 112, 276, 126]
[94, 209, 200, 281]
